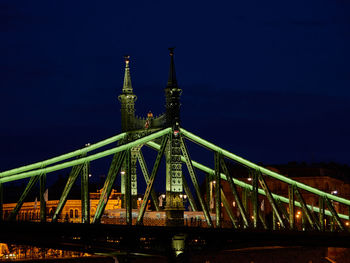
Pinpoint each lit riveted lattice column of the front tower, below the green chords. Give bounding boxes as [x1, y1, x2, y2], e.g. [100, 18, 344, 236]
[165, 132, 184, 226]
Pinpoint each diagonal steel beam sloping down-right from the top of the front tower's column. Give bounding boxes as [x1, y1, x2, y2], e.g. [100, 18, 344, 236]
[180, 137, 213, 227]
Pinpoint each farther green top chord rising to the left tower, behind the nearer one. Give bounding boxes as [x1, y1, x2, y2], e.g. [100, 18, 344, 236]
[0, 133, 126, 178]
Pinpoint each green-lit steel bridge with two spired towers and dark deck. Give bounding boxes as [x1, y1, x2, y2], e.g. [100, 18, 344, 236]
[0, 49, 350, 262]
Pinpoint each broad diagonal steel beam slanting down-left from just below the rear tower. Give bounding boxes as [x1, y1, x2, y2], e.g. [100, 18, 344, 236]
[92, 151, 125, 224]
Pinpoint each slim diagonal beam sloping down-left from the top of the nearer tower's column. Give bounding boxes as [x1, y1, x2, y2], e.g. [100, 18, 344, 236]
[136, 134, 169, 225]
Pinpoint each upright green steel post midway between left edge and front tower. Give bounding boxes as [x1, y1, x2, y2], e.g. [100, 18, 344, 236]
[81, 163, 90, 224]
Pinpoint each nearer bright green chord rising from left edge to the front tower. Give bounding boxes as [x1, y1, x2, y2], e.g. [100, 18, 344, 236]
[0, 128, 171, 183]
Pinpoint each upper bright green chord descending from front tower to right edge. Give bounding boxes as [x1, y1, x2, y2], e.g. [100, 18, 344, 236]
[181, 128, 350, 205]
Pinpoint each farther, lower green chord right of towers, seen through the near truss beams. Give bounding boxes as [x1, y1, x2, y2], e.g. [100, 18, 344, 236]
[146, 142, 349, 220]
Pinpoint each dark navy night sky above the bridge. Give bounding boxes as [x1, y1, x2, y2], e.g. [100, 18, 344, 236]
[0, 0, 350, 177]
